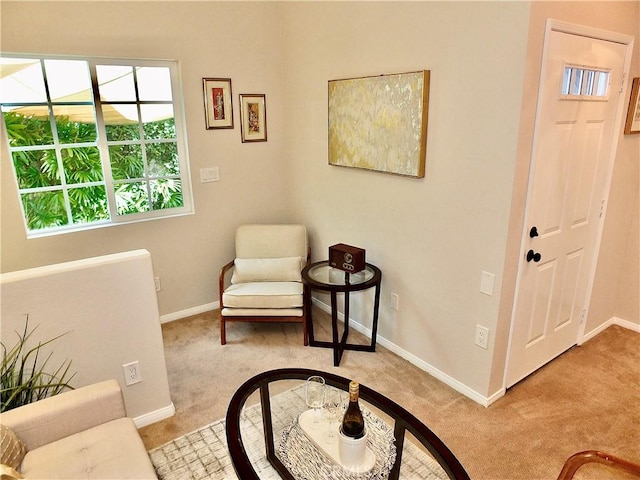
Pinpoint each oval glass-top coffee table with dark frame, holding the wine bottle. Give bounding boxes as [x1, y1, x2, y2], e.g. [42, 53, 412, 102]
[225, 368, 469, 480]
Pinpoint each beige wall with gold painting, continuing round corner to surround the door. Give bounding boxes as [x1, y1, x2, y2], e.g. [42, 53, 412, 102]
[283, 2, 640, 398]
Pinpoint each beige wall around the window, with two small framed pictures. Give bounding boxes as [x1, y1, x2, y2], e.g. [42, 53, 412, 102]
[0, 1, 289, 315]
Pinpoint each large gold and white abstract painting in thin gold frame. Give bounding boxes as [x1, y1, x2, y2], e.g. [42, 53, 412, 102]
[328, 70, 430, 178]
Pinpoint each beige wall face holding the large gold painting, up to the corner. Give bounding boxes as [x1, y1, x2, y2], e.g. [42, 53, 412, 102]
[283, 2, 529, 396]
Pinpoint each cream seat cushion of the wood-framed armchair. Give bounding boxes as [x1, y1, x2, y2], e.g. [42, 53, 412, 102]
[222, 282, 303, 308]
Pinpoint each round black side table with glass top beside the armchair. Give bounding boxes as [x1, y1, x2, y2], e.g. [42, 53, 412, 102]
[302, 260, 382, 367]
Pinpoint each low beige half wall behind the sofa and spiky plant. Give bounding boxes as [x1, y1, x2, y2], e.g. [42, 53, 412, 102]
[0, 250, 174, 426]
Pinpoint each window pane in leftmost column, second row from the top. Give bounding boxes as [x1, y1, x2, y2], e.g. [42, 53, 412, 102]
[2, 106, 53, 147]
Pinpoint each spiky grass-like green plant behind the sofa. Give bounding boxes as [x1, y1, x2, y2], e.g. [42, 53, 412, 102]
[0, 315, 76, 412]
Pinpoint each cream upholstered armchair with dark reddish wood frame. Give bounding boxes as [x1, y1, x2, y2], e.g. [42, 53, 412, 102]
[219, 225, 310, 345]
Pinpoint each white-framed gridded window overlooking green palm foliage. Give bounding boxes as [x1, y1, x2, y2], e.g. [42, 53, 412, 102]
[0, 55, 192, 236]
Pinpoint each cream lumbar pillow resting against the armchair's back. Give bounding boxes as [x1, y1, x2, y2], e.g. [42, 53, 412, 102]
[231, 257, 302, 284]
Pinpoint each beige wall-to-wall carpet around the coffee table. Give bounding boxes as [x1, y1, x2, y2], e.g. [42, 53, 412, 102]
[141, 310, 640, 480]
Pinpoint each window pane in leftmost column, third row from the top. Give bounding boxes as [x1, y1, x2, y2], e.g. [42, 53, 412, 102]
[12, 150, 61, 189]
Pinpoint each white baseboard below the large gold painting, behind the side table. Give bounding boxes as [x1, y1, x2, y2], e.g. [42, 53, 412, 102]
[312, 298, 496, 407]
